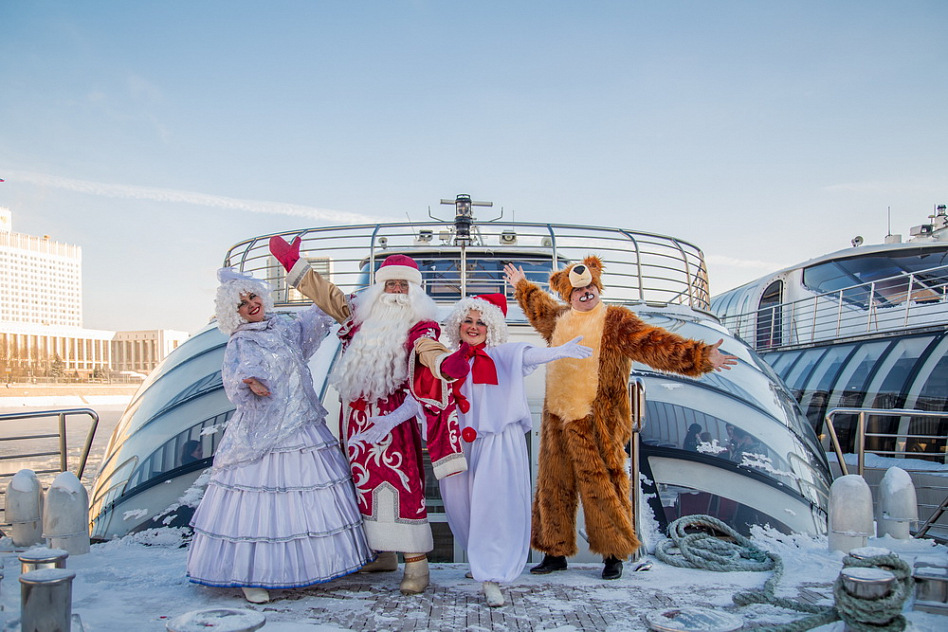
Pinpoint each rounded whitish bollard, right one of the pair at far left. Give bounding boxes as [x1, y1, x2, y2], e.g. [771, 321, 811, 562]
[43, 472, 89, 555]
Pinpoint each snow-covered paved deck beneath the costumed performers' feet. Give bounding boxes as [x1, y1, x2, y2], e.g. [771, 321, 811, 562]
[0, 529, 948, 632]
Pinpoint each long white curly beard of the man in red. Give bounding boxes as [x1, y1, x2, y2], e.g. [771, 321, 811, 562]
[330, 292, 427, 402]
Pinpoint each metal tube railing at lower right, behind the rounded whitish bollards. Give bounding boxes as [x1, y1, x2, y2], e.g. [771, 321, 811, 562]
[826, 407, 948, 537]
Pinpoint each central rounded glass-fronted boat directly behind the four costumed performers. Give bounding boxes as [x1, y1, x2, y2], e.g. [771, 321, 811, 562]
[91, 196, 831, 561]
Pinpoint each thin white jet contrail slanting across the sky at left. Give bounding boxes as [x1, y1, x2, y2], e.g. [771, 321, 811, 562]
[4, 171, 397, 224]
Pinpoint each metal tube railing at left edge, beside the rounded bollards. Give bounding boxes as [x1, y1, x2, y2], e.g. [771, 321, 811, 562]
[0, 408, 99, 526]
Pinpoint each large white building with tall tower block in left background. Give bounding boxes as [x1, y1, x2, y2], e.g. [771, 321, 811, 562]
[0, 208, 188, 381]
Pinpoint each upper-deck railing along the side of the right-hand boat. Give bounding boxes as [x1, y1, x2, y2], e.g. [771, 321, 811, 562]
[720, 266, 948, 351]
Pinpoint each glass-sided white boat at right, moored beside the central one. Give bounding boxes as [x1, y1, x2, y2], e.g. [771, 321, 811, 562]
[711, 206, 948, 539]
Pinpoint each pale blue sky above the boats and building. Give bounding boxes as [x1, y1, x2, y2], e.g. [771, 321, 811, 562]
[0, 0, 948, 331]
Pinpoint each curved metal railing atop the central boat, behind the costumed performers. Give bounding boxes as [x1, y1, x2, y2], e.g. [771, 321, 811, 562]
[224, 221, 710, 311]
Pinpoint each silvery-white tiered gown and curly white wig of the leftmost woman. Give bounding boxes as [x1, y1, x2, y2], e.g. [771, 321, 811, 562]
[188, 268, 373, 601]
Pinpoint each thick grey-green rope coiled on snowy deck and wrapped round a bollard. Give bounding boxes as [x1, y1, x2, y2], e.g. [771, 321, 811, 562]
[655, 515, 912, 632]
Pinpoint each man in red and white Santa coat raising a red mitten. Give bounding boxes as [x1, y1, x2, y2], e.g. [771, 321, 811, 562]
[270, 237, 470, 595]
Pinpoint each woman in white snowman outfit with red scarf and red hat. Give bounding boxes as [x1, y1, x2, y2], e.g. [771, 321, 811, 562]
[350, 294, 592, 607]
